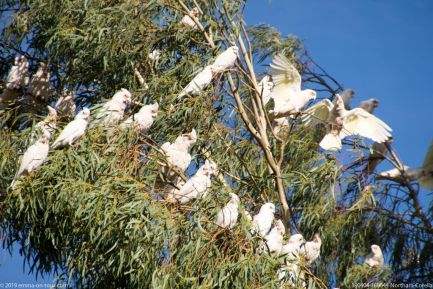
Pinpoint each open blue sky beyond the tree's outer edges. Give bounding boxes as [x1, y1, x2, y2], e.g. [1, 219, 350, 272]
[0, 0, 433, 283]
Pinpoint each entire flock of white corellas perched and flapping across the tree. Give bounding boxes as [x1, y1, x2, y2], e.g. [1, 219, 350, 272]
[0, 9, 433, 284]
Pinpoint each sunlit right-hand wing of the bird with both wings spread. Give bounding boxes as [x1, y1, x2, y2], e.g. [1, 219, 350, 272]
[340, 108, 392, 143]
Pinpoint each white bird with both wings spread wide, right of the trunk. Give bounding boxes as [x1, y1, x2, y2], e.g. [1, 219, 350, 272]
[303, 94, 392, 150]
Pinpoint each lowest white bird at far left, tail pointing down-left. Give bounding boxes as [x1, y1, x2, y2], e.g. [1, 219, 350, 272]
[11, 131, 51, 188]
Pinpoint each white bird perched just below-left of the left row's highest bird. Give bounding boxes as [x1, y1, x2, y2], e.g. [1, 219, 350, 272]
[53, 108, 90, 148]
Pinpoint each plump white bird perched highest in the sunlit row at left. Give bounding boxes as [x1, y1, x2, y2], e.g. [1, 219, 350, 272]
[94, 88, 131, 125]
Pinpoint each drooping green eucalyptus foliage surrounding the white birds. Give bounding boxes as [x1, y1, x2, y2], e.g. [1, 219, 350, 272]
[0, 0, 433, 288]
